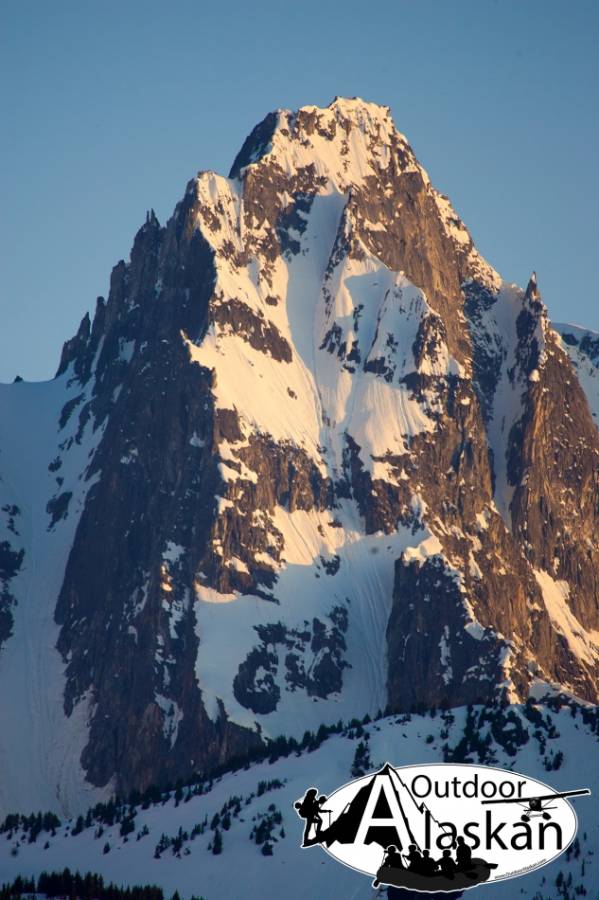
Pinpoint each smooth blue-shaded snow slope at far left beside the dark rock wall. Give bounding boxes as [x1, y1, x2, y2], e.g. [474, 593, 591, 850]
[0, 373, 111, 811]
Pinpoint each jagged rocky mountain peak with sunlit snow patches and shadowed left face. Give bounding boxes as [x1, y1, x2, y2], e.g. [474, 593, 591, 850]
[0, 100, 599, 791]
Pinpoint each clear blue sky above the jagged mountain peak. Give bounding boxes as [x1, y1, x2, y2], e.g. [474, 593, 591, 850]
[0, 0, 599, 381]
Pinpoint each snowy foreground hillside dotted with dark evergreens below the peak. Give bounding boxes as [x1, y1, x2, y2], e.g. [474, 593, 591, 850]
[0, 704, 599, 900]
